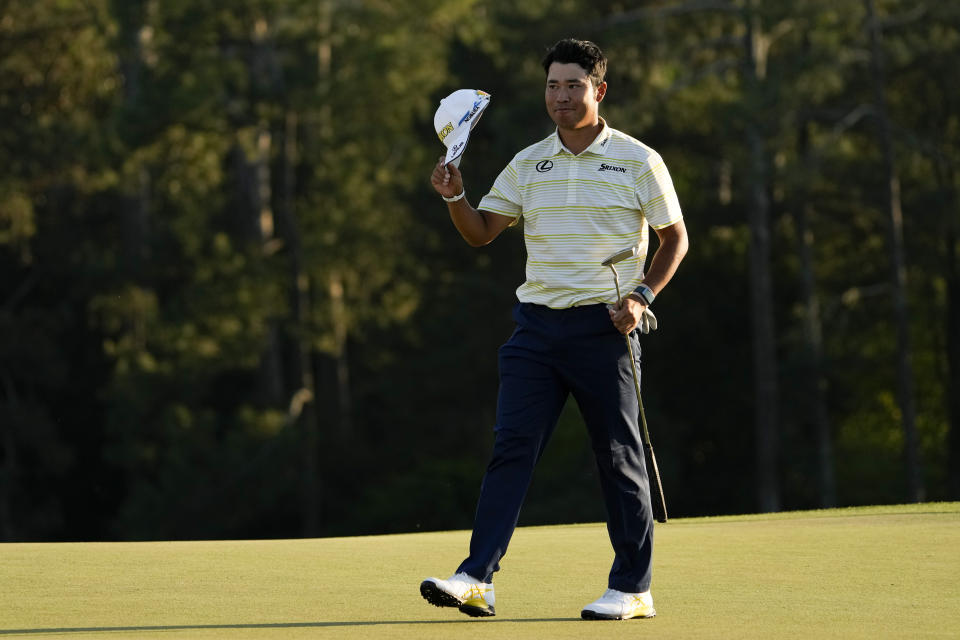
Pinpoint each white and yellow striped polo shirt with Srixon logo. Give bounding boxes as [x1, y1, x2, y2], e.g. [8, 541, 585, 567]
[478, 118, 683, 309]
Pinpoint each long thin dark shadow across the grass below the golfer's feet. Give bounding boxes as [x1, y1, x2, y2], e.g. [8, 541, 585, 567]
[0, 618, 580, 636]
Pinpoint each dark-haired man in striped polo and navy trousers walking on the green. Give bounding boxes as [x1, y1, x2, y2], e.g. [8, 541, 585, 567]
[420, 39, 687, 619]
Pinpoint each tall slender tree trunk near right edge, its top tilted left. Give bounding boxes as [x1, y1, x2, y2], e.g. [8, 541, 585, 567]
[864, 0, 925, 502]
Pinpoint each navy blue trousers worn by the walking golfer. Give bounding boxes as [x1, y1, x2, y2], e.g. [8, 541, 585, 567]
[457, 303, 653, 593]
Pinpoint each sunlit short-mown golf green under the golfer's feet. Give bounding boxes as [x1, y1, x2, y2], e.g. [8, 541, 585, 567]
[0, 503, 960, 640]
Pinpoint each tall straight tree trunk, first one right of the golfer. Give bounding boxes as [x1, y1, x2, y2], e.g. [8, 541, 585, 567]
[744, 3, 780, 512]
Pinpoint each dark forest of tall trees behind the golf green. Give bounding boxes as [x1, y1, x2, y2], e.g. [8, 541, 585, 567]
[0, 0, 960, 541]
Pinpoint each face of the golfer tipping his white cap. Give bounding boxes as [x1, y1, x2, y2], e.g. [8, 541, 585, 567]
[545, 62, 607, 129]
